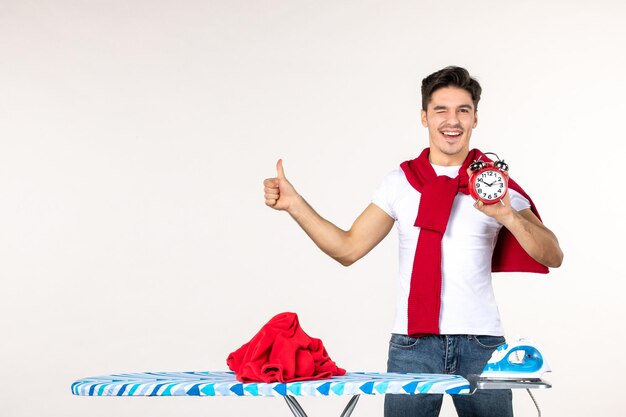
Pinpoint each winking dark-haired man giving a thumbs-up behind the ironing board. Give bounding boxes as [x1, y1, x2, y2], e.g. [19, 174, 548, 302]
[264, 67, 563, 417]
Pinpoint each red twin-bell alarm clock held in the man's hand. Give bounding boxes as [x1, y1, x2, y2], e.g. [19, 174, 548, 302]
[468, 152, 509, 204]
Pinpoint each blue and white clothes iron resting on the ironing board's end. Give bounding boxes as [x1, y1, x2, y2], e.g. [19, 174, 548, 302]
[469, 339, 551, 389]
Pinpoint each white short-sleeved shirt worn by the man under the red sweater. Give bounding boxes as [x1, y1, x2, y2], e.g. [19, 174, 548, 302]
[372, 165, 530, 336]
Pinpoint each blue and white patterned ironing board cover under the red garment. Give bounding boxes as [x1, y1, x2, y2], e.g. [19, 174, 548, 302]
[72, 372, 470, 397]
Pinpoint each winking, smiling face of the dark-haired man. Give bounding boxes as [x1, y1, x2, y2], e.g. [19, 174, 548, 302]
[422, 87, 478, 166]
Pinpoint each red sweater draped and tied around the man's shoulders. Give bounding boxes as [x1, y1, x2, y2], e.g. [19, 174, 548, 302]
[400, 148, 548, 337]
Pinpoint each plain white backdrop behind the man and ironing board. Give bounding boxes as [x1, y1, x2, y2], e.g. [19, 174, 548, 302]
[0, 0, 626, 417]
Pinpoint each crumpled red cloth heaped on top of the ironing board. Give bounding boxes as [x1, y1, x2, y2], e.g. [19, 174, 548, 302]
[226, 313, 346, 383]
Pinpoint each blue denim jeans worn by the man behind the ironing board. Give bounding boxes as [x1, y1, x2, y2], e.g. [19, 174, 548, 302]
[385, 334, 513, 417]
